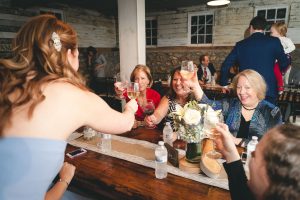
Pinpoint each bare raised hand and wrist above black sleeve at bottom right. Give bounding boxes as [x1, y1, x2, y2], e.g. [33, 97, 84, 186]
[215, 123, 240, 163]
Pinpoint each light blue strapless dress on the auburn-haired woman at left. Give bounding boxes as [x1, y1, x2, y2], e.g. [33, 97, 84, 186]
[0, 137, 66, 200]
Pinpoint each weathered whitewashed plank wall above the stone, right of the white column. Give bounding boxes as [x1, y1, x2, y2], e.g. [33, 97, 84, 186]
[146, 0, 300, 47]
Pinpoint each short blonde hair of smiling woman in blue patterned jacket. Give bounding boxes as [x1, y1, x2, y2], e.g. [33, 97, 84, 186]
[232, 69, 267, 100]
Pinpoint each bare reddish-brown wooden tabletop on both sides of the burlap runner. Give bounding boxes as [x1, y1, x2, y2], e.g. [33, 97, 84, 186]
[65, 127, 230, 200]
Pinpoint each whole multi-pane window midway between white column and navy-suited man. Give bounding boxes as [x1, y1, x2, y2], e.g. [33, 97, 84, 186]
[189, 13, 214, 44]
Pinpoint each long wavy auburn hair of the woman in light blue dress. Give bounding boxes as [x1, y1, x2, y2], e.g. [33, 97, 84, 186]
[0, 15, 87, 135]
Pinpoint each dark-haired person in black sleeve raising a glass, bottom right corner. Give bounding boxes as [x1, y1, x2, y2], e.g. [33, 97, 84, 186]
[216, 124, 300, 200]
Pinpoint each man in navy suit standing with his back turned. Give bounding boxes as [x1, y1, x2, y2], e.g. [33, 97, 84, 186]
[220, 16, 288, 104]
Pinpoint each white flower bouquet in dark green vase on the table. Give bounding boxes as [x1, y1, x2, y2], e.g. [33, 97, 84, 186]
[170, 101, 207, 162]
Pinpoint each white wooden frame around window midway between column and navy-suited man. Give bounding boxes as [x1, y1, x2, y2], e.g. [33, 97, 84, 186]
[187, 11, 215, 46]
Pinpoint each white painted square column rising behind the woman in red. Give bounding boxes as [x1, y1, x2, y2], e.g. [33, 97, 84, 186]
[118, 0, 146, 80]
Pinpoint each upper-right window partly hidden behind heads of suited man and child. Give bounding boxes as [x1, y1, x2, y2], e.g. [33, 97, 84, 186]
[256, 6, 288, 35]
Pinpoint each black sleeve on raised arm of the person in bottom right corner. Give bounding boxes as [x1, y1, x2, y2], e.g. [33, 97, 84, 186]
[223, 160, 255, 200]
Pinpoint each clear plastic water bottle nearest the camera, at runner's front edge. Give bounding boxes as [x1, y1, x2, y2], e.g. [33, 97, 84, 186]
[155, 141, 168, 179]
